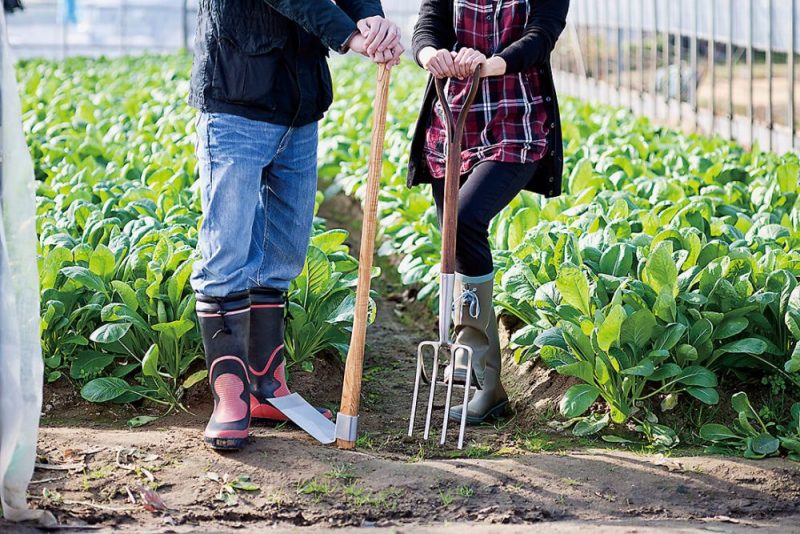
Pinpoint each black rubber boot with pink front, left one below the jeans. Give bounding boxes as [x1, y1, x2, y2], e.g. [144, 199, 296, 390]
[197, 292, 250, 450]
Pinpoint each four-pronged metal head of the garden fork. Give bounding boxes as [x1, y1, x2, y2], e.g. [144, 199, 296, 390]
[408, 341, 473, 449]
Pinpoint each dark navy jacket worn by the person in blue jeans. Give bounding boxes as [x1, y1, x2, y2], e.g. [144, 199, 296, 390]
[189, 0, 383, 126]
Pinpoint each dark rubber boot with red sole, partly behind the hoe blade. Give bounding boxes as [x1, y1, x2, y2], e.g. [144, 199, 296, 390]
[248, 288, 333, 422]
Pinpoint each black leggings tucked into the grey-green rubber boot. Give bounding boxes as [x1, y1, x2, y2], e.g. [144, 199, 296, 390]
[432, 161, 538, 276]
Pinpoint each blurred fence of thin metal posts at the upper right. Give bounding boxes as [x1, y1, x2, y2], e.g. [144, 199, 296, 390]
[553, 0, 800, 152]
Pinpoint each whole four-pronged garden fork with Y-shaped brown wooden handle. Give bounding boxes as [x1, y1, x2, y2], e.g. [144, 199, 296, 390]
[408, 65, 481, 449]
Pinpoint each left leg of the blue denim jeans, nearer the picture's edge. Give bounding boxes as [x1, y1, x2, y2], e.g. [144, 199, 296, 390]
[191, 113, 288, 297]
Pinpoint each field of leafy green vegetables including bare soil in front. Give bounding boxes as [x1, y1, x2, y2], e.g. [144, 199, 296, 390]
[10, 56, 800, 531]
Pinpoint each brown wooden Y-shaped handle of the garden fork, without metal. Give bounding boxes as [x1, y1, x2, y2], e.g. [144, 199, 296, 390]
[436, 65, 481, 274]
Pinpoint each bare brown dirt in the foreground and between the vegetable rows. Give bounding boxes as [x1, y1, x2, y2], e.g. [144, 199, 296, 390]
[9, 195, 800, 534]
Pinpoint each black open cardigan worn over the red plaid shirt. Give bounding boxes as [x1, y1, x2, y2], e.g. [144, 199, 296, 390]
[408, 0, 569, 197]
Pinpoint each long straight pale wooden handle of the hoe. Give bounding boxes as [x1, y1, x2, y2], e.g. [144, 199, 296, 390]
[336, 65, 391, 449]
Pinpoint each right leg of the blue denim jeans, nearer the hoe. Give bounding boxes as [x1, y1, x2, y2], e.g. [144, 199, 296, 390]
[254, 123, 317, 291]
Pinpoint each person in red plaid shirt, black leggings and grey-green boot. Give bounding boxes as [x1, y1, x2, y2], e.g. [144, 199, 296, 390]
[408, 0, 569, 424]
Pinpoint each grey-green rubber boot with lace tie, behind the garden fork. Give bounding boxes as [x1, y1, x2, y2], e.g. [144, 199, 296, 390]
[446, 274, 508, 425]
